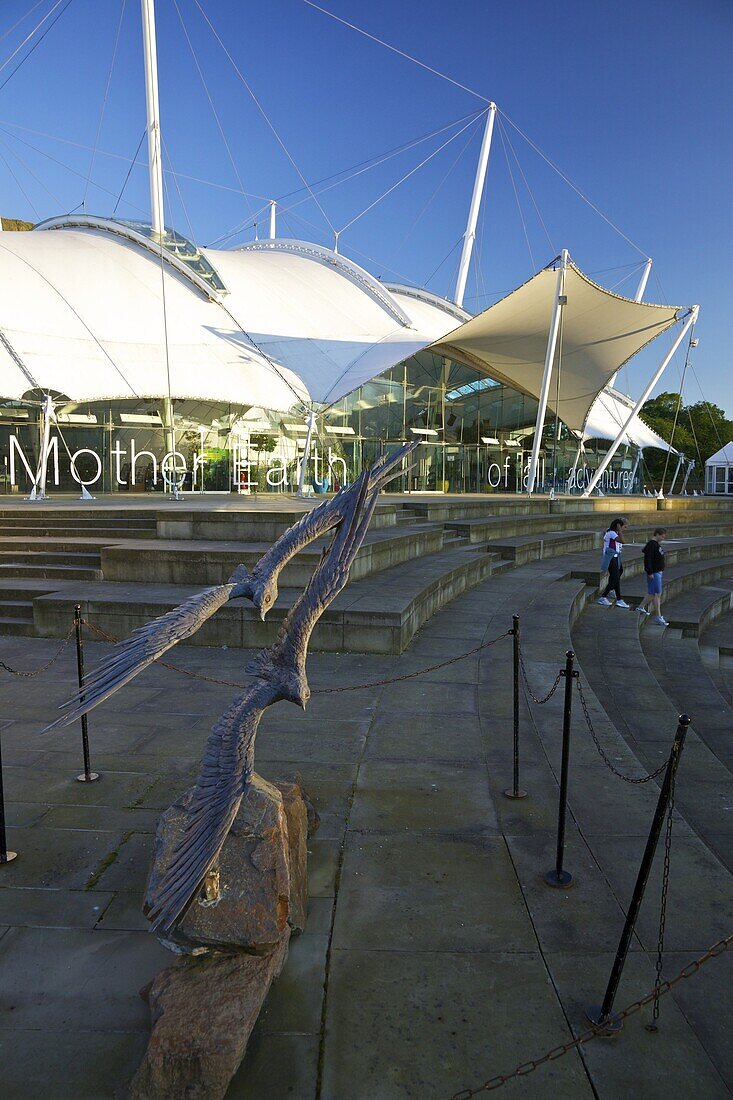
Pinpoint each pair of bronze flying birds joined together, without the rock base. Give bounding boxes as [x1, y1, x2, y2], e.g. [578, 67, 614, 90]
[46, 442, 417, 935]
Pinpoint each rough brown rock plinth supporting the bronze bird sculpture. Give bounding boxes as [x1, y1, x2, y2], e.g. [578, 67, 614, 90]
[129, 774, 317, 1100]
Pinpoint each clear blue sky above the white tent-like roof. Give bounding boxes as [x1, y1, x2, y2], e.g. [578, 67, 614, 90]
[0, 0, 733, 414]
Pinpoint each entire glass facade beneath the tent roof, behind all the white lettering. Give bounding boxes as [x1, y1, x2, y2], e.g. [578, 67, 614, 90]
[0, 352, 642, 493]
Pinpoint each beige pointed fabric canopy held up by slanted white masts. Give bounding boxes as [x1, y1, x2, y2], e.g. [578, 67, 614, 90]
[431, 263, 678, 436]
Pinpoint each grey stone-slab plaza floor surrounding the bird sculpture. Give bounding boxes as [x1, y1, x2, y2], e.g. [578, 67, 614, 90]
[0, 501, 733, 1100]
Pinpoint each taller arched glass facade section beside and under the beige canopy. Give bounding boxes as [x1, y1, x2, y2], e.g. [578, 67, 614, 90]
[320, 352, 642, 493]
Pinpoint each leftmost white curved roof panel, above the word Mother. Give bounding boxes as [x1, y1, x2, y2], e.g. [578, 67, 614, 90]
[0, 221, 306, 409]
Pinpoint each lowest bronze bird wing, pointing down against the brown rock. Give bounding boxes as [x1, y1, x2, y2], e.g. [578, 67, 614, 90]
[146, 681, 278, 933]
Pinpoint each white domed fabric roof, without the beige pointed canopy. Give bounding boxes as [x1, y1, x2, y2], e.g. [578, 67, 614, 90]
[0, 225, 469, 411]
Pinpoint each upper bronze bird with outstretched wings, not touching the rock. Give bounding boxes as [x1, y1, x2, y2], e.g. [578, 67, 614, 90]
[44, 440, 419, 733]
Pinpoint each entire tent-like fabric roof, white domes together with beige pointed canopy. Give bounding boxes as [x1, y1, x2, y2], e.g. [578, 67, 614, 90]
[0, 223, 678, 437]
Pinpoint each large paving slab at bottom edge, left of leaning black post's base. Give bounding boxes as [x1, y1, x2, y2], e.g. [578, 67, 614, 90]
[320, 950, 594, 1100]
